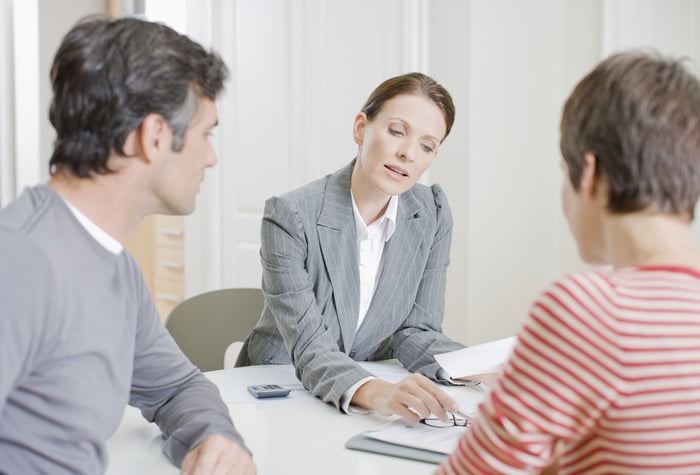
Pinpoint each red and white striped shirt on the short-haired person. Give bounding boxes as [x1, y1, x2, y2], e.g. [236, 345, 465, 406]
[437, 266, 700, 475]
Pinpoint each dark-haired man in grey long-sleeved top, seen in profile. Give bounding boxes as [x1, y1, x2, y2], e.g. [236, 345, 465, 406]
[0, 14, 255, 474]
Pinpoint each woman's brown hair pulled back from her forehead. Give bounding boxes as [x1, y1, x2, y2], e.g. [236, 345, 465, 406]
[362, 73, 455, 140]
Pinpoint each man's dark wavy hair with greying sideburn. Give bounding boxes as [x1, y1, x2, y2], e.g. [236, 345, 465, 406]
[49, 17, 228, 178]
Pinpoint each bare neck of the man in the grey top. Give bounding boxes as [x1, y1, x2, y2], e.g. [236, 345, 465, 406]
[47, 172, 150, 242]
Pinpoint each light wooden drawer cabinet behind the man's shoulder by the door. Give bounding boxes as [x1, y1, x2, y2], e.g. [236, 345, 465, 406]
[124, 215, 185, 322]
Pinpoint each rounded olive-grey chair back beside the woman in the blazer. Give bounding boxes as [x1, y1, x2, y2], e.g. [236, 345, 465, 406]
[165, 289, 263, 371]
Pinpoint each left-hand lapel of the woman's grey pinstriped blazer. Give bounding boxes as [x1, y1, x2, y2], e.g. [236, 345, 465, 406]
[316, 161, 360, 351]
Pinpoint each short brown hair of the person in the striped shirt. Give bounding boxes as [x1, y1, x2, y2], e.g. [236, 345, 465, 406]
[560, 52, 700, 218]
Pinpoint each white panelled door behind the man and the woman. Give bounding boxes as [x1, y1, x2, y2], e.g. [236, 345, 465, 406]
[185, 0, 424, 295]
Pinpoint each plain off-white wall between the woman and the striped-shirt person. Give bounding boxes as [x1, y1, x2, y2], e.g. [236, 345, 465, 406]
[429, 0, 601, 343]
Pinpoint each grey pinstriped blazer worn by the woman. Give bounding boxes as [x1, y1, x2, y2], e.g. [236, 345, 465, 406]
[236, 161, 463, 407]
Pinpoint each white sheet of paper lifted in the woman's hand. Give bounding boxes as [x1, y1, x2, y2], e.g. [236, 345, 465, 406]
[435, 336, 517, 379]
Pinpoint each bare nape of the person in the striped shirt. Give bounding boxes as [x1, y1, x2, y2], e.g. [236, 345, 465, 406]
[603, 211, 700, 270]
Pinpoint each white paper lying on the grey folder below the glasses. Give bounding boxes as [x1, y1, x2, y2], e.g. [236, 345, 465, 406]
[362, 422, 467, 454]
